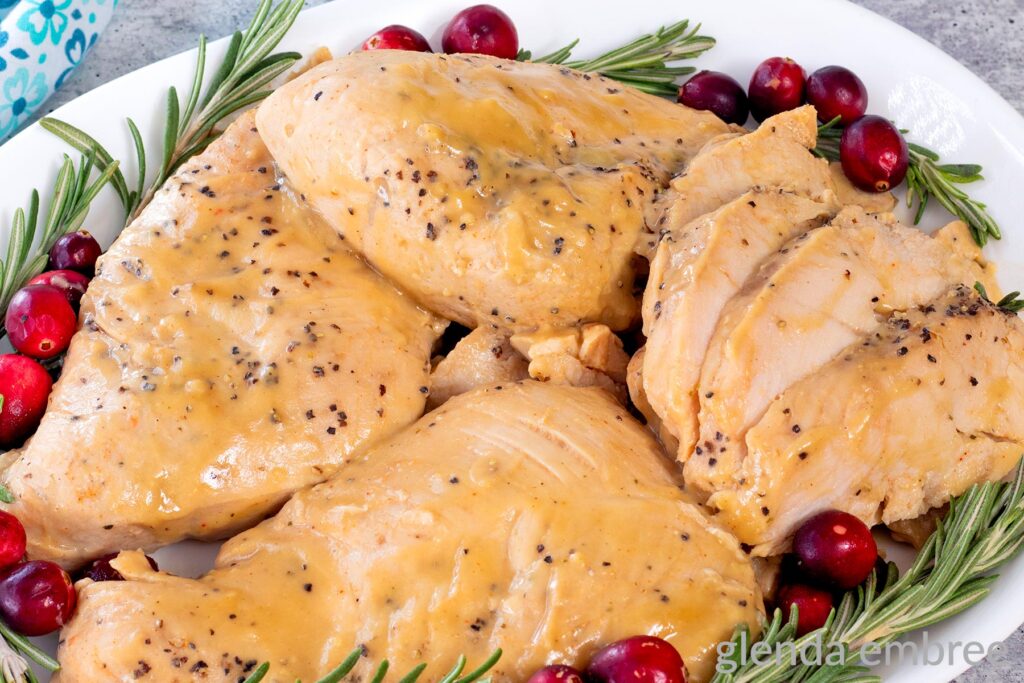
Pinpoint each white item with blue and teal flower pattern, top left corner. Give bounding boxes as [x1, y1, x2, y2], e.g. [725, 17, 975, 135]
[0, 0, 118, 141]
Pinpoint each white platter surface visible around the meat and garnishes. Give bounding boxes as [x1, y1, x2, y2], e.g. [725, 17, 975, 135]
[6, 0, 1024, 683]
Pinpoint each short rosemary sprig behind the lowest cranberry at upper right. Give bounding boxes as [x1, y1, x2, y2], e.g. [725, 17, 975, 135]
[814, 117, 1002, 247]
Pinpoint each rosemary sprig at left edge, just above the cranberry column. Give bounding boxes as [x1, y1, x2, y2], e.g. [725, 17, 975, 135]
[0, 156, 118, 337]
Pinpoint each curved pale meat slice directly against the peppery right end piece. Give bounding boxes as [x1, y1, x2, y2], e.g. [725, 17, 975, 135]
[692, 207, 995, 493]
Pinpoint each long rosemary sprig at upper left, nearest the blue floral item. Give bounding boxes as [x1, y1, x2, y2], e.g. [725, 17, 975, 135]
[40, 0, 303, 225]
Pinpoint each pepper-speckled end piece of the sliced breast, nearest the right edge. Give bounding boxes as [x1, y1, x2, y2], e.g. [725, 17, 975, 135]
[708, 286, 1024, 555]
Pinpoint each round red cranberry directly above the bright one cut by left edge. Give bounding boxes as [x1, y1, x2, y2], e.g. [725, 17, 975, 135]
[4, 285, 78, 358]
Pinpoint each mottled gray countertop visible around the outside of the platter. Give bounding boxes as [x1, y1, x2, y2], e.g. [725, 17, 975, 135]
[29, 0, 1024, 683]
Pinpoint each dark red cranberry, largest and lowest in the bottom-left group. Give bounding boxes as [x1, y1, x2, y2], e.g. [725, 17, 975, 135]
[0, 560, 76, 636]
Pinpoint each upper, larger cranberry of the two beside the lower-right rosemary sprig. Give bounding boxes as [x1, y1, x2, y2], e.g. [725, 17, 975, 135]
[793, 510, 879, 591]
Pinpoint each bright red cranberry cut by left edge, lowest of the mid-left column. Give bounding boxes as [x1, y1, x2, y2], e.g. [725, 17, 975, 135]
[0, 353, 53, 446]
